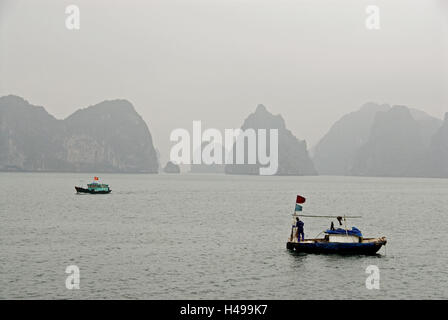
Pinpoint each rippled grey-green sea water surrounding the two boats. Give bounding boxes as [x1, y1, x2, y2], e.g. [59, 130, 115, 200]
[0, 173, 448, 299]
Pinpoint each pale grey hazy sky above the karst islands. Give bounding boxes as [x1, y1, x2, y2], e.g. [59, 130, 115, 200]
[0, 0, 448, 161]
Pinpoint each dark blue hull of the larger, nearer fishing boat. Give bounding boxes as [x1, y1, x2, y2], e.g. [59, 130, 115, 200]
[286, 238, 387, 255]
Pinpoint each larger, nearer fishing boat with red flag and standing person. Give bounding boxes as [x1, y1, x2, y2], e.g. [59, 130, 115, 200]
[286, 196, 387, 255]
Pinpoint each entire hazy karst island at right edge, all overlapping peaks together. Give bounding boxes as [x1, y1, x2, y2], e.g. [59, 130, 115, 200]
[313, 103, 448, 177]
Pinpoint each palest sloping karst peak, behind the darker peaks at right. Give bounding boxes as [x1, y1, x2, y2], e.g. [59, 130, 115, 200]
[313, 103, 390, 175]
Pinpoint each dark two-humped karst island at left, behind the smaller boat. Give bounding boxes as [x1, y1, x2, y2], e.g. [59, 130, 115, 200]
[0, 96, 158, 173]
